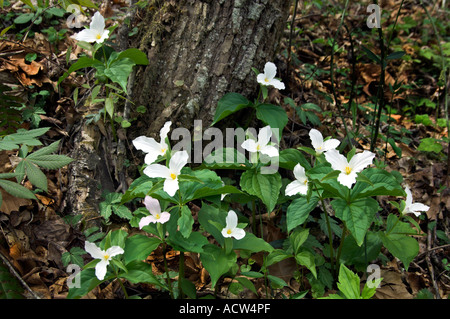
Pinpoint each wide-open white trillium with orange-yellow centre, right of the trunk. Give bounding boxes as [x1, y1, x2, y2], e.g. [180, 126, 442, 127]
[325, 149, 375, 188]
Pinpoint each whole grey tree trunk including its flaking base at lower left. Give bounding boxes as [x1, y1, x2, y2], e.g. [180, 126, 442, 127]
[65, 0, 290, 220]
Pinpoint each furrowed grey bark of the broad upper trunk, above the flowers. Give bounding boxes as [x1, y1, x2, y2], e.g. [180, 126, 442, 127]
[128, 0, 291, 136]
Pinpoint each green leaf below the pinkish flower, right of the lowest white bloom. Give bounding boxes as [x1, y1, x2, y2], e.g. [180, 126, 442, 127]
[123, 234, 161, 264]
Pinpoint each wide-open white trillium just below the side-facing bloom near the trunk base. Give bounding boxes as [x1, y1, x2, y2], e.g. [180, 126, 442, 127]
[144, 151, 189, 196]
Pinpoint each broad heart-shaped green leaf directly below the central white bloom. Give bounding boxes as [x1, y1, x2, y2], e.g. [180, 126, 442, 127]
[240, 170, 282, 212]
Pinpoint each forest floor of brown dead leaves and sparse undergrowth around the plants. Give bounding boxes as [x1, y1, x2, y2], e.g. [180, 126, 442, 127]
[0, 0, 450, 299]
